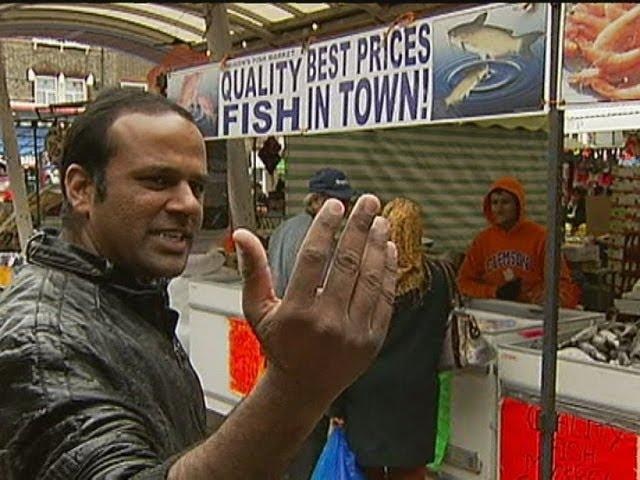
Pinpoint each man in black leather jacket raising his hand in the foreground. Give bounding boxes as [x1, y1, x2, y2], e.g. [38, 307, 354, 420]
[0, 91, 396, 480]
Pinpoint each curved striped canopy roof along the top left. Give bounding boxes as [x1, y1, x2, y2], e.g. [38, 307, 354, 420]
[0, 3, 479, 62]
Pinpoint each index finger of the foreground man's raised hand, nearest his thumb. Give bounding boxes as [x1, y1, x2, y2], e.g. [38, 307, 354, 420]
[285, 198, 344, 305]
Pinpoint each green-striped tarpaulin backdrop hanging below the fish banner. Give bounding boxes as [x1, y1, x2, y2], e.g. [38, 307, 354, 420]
[286, 121, 548, 253]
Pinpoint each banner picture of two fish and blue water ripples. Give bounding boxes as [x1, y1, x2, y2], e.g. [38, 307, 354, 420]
[433, 5, 547, 119]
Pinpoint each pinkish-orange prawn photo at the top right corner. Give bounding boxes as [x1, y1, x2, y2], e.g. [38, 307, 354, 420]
[564, 3, 640, 100]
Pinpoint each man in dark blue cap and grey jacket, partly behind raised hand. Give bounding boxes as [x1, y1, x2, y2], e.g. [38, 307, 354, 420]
[268, 168, 354, 480]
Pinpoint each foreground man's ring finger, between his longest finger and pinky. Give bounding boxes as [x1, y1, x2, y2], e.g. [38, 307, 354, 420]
[349, 217, 389, 329]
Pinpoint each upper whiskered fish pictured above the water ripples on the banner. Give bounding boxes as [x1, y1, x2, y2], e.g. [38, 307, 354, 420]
[448, 12, 544, 60]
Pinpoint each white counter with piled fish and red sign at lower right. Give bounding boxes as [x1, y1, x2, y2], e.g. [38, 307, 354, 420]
[498, 322, 640, 480]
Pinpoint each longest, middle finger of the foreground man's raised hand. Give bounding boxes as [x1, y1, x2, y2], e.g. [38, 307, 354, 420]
[322, 195, 386, 313]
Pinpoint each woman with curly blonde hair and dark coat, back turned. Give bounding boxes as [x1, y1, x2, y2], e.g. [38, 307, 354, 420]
[336, 198, 451, 480]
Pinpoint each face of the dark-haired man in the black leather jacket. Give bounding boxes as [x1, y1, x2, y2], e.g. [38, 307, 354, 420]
[86, 112, 206, 280]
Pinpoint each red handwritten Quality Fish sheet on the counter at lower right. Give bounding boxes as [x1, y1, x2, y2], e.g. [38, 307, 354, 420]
[500, 396, 640, 480]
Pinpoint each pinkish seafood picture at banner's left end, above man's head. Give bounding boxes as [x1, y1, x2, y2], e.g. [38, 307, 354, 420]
[167, 63, 220, 139]
